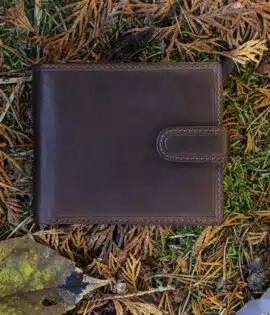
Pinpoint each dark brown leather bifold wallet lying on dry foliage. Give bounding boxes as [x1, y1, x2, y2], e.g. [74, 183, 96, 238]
[33, 63, 227, 225]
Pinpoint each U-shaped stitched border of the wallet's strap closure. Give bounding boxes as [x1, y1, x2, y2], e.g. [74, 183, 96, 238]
[157, 127, 226, 161]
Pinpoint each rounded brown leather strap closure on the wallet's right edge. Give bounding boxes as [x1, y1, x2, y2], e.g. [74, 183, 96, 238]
[157, 126, 228, 163]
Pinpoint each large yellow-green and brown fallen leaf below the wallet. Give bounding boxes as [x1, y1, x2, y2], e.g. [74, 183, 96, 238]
[0, 236, 111, 315]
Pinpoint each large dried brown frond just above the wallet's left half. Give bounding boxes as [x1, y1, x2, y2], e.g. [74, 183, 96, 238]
[38, 0, 125, 62]
